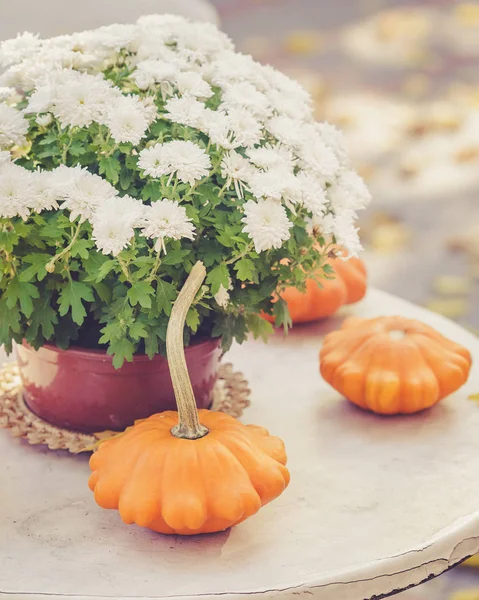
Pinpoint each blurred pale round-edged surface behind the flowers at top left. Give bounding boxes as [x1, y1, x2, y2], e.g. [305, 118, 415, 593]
[0, 0, 218, 40]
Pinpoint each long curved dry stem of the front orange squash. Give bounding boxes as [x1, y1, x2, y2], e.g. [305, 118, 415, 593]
[166, 261, 208, 440]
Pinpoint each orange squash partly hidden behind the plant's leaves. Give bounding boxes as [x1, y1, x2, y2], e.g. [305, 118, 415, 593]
[263, 250, 367, 323]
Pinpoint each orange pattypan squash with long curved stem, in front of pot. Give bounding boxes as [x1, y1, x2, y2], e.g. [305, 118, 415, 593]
[89, 263, 289, 535]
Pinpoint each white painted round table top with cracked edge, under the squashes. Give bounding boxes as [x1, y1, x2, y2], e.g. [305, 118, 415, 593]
[0, 291, 479, 600]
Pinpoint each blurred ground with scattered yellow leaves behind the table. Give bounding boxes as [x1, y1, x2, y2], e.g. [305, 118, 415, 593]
[213, 0, 479, 600]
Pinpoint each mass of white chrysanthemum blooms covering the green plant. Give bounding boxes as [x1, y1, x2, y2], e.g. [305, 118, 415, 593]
[0, 15, 370, 272]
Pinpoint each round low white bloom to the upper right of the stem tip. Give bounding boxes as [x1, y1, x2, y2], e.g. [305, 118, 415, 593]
[242, 200, 293, 252]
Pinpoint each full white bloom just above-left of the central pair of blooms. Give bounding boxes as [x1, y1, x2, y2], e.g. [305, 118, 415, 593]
[105, 96, 151, 146]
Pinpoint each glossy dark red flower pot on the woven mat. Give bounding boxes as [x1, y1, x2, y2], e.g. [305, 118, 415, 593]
[16, 339, 221, 433]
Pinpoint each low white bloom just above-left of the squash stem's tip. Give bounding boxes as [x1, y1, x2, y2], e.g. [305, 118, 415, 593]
[143, 198, 195, 253]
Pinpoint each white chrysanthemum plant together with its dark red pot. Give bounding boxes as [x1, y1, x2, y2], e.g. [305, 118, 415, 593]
[0, 16, 369, 430]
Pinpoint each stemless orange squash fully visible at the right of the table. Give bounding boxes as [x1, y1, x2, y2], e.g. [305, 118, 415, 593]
[320, 317, 472, 415]
